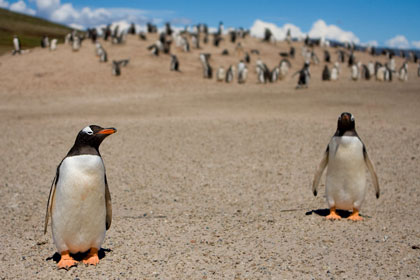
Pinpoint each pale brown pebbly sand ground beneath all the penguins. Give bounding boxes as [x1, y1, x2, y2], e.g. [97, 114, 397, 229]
[0, 36, 420, 279]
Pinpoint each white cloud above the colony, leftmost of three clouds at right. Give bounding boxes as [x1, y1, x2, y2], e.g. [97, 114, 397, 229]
[250, 19, 304, 40]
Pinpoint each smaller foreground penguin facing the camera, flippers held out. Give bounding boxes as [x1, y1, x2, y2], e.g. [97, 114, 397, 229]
[312, 113, 379, 221]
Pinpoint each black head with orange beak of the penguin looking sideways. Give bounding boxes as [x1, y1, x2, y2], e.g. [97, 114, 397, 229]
[74, 125, 117, 149]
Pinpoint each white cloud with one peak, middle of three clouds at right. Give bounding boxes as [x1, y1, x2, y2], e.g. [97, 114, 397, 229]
[308, 19, 360, 44]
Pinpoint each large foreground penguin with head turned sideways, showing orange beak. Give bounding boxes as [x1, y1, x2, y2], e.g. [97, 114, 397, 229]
[44, 125, 117, 269]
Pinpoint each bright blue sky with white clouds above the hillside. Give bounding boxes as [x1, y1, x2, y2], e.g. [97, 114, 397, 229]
[0, 0, 420, 48]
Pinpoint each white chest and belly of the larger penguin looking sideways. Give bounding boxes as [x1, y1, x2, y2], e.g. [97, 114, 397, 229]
[52, 155, 106, 253]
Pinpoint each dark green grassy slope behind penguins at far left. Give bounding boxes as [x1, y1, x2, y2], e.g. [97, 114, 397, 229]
[0, 8, 71, 55]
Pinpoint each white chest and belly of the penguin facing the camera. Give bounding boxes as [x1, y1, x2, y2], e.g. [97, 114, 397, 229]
[326, 136, 366, 210]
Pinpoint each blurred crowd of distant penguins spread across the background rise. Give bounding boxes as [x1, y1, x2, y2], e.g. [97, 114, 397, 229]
[12, 22, 420, 85]
